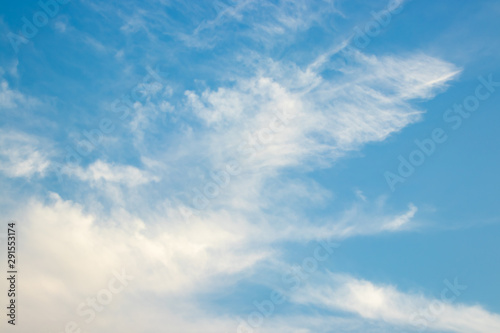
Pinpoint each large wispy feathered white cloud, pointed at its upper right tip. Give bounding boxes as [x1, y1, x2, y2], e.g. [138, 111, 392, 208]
[182, 52, 458, 178]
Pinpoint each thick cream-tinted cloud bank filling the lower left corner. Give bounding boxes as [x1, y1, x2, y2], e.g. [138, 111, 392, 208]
[12, 194, 266, 332]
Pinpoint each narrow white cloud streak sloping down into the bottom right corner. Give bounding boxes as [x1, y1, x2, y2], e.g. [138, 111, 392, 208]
[293, 274, 500, 333]
